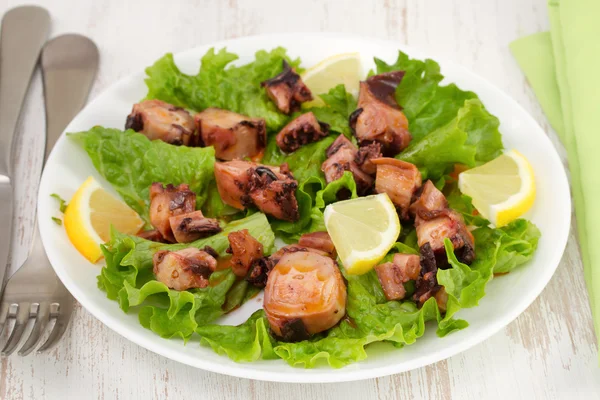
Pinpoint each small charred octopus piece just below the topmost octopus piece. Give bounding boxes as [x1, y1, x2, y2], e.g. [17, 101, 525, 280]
[277, 112, 329, 153]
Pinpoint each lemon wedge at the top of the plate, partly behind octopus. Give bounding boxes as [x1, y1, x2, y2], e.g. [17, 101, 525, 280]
[302, 53, 362, 107]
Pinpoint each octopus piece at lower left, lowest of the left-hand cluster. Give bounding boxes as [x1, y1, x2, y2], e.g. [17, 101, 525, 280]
[152, 247, 217, 290]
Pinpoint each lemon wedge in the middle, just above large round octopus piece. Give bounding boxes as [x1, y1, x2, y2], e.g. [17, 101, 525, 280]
[324, 193, 400, 275]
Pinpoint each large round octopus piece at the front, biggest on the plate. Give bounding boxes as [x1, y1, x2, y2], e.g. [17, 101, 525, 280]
[264, 251, 346, 342]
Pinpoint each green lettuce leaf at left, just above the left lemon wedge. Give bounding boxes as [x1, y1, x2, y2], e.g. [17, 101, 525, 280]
[69, 126, 215, 224]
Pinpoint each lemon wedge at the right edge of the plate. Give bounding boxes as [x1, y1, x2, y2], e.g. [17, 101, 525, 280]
[458, 150, 535, 227]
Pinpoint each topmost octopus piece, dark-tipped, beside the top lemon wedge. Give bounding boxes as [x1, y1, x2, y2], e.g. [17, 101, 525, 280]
[260, 60, 313, 114]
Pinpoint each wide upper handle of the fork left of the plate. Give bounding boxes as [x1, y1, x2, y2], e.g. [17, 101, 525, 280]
[41, 34, 99, 163]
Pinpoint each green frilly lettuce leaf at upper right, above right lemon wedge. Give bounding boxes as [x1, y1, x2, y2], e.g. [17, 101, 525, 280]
[375, 52, 503, 179]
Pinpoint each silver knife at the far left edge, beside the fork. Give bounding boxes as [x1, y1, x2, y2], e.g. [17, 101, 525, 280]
[0, 6, 50, 292]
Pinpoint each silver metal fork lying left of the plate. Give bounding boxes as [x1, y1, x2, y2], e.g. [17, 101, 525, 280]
[0, 34, 99, 356]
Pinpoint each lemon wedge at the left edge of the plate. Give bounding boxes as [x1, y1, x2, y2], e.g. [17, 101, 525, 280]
[64, 176, 144, 263]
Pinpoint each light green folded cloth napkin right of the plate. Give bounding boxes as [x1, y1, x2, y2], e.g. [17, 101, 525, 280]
[510, 0, 600, 356]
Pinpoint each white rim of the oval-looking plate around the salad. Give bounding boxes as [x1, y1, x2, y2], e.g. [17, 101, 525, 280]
[37, 32, 571, 383]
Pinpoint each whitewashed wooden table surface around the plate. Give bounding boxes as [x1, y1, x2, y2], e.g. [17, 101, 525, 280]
[0, 0, 600, 399]
